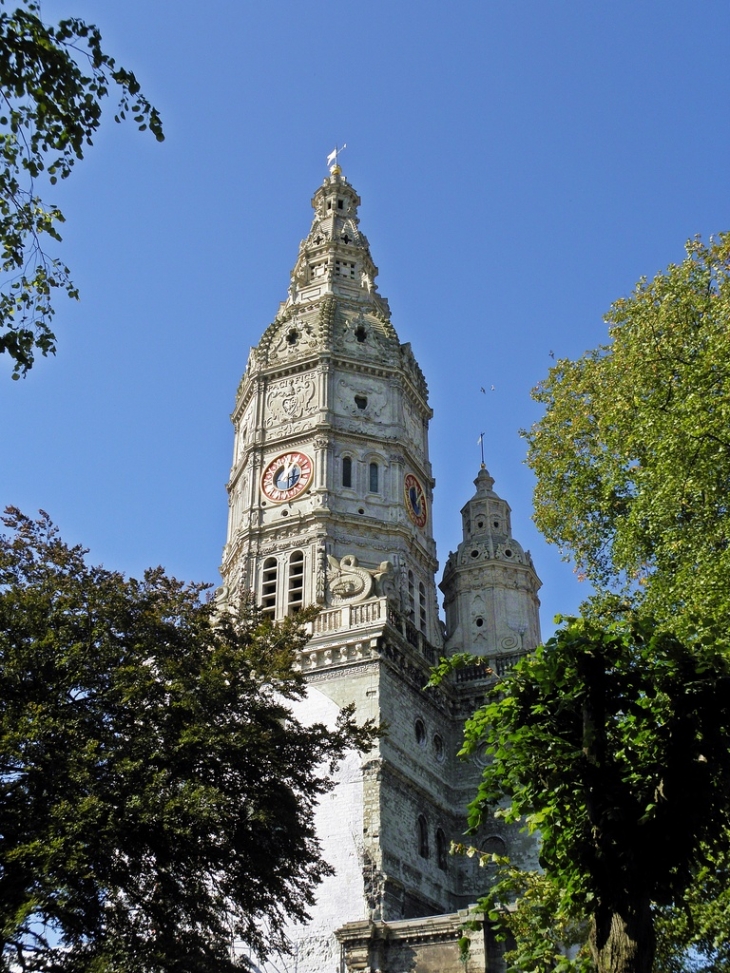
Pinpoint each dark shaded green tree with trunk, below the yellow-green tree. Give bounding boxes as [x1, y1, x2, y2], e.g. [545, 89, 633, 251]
[463, 616, 730, 973]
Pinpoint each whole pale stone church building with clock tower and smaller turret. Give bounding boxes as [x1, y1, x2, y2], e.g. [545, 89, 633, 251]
[221, 166, 540, 973]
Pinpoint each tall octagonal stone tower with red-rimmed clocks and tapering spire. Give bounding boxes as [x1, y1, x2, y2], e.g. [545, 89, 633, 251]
[222, 166, 441, 640]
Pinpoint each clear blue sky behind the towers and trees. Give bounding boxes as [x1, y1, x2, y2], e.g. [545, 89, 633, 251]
[0, 0, 730, 630]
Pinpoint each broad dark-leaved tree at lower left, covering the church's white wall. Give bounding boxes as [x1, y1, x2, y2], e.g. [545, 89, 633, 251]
[0, 510, 373, 973]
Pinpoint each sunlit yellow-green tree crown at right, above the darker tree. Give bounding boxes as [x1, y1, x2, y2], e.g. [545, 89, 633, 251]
[526, 234, 730, 638]
